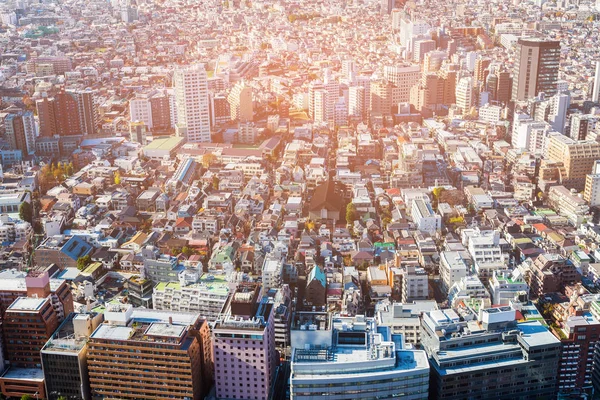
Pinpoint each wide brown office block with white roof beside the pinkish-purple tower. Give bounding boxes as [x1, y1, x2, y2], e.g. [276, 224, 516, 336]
[87, 304, 212, 400]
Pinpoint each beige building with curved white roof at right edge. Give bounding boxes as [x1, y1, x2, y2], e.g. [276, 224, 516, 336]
[547, 134, 600, 190]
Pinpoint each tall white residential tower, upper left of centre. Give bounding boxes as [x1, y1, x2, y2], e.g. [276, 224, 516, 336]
[173, 64, 211, 143]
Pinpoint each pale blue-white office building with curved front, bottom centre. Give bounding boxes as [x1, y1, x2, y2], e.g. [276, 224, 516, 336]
[290, 315, 429, 400]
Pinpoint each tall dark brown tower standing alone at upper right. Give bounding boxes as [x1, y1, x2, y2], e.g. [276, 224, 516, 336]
[512, 38, 560, 101]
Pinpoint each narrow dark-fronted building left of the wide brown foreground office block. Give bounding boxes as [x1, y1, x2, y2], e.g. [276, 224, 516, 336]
[41, 313, 103, 400]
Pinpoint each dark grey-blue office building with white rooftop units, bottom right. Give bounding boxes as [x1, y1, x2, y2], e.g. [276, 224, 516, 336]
[421, 306, 561, 400]
